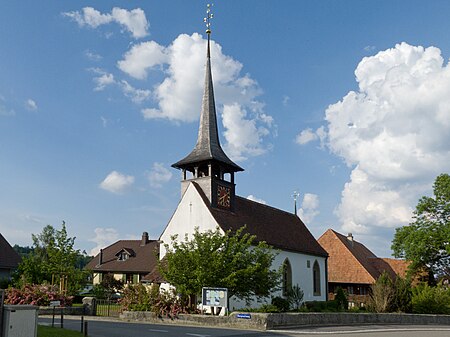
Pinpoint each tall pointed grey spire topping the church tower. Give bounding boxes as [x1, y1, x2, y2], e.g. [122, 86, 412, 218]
[172, 5, 243, 172]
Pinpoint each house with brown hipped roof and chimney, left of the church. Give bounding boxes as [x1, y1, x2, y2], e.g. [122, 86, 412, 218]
[86, 232, 159, 284]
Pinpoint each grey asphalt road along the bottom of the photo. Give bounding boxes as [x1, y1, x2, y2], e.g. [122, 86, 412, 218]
[39, 318, 450, 337]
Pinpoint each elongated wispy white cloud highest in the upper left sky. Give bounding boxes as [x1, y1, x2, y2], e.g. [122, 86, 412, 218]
[63, 7, 149, 39]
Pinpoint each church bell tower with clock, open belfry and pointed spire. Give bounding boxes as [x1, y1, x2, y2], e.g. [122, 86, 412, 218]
[172, 5, 244, 211]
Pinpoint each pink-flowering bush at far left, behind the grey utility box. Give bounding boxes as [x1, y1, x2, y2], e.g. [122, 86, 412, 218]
[5, 284, 73, 306]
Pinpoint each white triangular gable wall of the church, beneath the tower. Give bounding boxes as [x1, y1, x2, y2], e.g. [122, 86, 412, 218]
[160, 183, 222, 259]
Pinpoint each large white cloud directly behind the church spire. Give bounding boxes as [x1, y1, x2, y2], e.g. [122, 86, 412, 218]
[117, 33, 275, 160]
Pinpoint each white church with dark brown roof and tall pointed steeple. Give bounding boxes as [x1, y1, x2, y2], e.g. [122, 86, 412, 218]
[159, 17, 328, 309]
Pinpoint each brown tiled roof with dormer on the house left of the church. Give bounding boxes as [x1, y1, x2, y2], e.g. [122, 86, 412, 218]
[86, 240, 159, 274]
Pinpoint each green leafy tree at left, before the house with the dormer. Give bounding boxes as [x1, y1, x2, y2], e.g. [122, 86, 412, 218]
[15, 222, 88, 295]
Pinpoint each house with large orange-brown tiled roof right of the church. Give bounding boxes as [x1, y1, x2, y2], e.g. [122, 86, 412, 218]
[318, 229, 409, 304]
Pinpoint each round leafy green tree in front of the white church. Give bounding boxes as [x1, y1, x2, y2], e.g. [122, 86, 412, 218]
[159, 227, 280, 301]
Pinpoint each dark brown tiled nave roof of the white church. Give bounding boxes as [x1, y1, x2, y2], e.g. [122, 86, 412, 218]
[193, 182, 328, 257]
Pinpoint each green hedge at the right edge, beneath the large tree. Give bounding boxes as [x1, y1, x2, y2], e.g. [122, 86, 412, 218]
[411, 284, 450, 315]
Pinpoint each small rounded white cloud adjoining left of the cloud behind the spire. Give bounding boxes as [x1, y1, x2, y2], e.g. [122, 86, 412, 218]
[117, 41, 167, 80]
